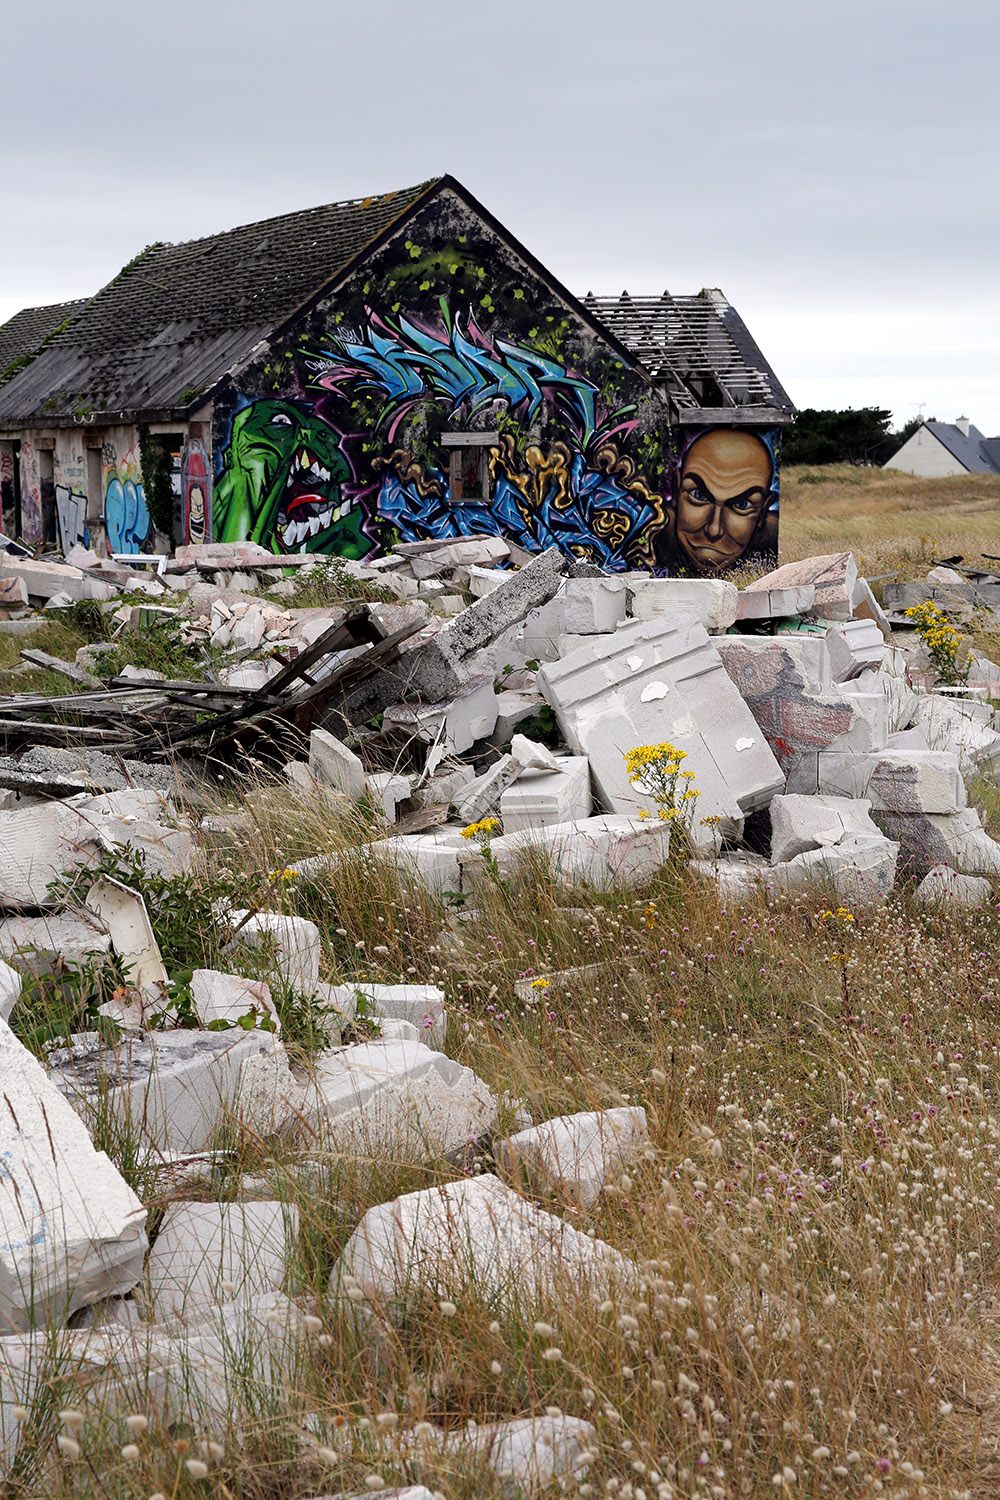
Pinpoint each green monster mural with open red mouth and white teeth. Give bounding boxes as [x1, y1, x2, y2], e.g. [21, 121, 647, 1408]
[213, 401, 373, 560]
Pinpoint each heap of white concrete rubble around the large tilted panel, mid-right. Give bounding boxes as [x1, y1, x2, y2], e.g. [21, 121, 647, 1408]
[277, 537, 1000, 903]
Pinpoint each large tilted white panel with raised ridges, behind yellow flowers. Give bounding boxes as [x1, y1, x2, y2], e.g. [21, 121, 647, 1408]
[538, 618, 784, 828]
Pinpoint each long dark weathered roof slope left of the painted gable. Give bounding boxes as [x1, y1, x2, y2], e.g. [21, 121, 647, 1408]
[0, 179, 438, 428]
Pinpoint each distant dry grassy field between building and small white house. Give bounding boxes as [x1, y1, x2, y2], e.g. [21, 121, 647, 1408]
[780, 464, 1000, 578]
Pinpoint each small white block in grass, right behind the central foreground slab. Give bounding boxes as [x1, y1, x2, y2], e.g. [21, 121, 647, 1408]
[496, 1106, 649, 1208]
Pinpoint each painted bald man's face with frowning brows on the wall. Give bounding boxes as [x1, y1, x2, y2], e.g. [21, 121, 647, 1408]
[675, 428, 774, 573]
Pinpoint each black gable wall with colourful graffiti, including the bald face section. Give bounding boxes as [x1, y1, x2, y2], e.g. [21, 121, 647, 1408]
[209, 192, 778, 573]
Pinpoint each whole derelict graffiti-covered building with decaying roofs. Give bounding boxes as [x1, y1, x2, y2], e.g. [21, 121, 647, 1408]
[0, 176, 795, 575]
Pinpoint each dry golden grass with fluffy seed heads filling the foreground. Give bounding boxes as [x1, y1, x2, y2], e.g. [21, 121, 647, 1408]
[7, 789, 1000, 1500]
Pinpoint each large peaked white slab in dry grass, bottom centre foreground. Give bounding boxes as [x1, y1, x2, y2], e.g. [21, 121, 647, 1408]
[330, 1173, 636, 1320]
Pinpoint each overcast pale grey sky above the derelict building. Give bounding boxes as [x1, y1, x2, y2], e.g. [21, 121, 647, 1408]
[0, 0, 1000, 434]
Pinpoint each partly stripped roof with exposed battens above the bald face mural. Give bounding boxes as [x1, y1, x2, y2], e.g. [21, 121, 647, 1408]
[583, 288, 795, 417]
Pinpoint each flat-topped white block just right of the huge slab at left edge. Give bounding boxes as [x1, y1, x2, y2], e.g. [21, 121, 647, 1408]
[49, 1029, 294, 1158]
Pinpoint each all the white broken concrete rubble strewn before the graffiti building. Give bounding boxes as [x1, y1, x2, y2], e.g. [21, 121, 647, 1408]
[0, 537, 1000, 1476]
